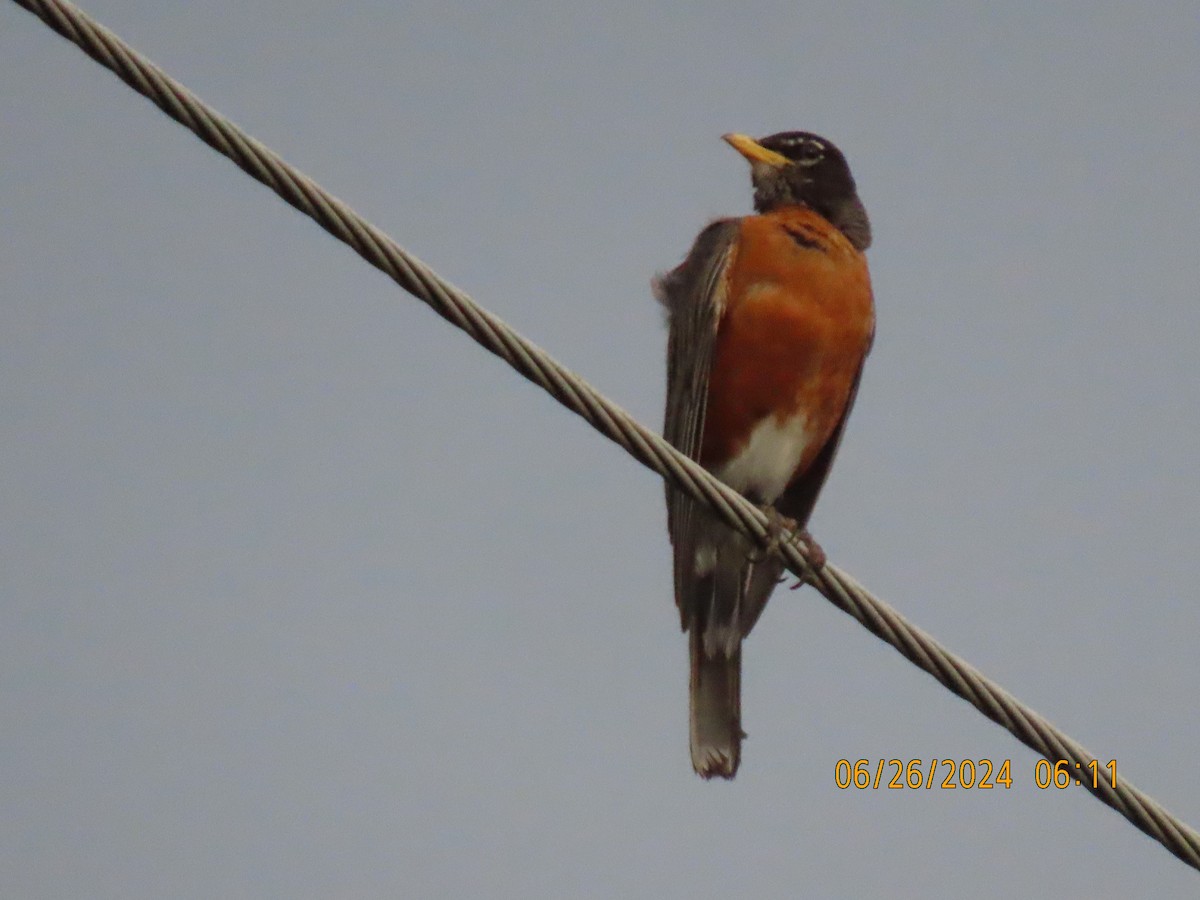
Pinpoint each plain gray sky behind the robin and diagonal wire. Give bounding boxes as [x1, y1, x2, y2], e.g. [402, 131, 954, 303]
[0, 0, 1200, 898]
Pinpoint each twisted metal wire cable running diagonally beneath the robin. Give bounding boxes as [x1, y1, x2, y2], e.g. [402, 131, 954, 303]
[13, 0, 1200, 869]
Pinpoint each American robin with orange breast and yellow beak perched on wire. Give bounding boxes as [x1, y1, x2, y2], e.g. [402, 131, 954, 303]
[655, 131, 875, 778]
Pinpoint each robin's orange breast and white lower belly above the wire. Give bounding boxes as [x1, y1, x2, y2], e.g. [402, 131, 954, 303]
[701, 208, 875, 503]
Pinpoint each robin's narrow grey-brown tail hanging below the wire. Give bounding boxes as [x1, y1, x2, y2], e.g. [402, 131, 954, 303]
[688, 623, 745, 778]
